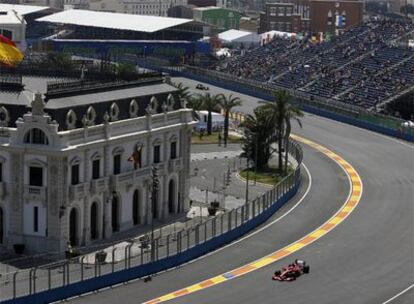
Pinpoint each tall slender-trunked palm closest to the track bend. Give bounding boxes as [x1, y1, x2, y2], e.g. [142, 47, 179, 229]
[260, 90, 303, 172]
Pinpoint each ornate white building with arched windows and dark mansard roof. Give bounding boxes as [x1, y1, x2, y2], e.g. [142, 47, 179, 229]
[0, 78, 193, 253]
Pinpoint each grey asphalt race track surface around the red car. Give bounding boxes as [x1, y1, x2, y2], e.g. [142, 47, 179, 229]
[66, 79, 414, 304]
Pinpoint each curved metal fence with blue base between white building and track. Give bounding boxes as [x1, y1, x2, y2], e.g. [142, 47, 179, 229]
[0, 142, 303, 303]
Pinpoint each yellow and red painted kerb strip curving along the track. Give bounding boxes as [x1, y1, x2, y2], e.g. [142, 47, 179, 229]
[144, 135, 363, 304]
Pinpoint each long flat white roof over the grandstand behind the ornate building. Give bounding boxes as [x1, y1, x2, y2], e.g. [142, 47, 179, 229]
[36, 9, 193, 33]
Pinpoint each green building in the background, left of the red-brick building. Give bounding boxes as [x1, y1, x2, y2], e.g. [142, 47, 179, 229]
[194, 6, 241, 30]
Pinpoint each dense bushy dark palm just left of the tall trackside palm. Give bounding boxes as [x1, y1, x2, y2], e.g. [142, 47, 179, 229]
[240, 107, 274, 171]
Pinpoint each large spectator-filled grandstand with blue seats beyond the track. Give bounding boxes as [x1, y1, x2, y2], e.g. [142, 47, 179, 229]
[212, 19, 414, 116]
